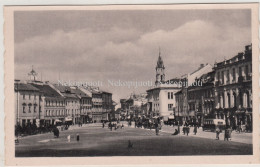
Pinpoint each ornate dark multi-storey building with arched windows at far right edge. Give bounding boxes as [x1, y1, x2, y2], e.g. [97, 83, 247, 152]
[214, 45, 252, 129]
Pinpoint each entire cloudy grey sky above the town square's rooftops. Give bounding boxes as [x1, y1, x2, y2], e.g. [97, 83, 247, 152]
[14, 9, 251, 102]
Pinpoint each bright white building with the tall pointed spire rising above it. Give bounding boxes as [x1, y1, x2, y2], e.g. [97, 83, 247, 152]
[146, 53, 180, 117]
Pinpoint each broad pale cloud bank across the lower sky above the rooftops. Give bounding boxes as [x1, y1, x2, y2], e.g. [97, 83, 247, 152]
[15, 20, 251, 101]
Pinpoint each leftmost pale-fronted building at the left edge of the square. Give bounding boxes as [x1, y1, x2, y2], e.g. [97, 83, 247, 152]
[14, 82, 43, 127]
